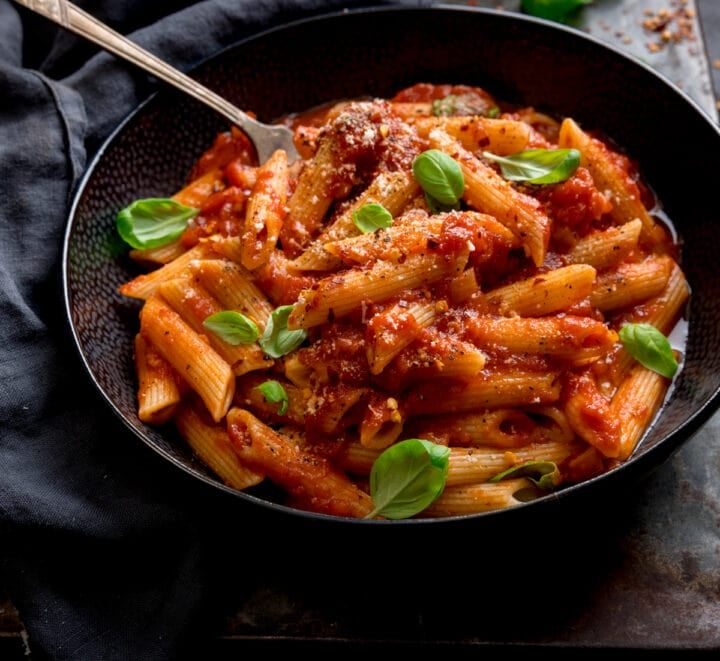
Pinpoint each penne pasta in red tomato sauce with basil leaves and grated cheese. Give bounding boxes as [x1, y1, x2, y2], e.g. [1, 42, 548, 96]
[63, 3, 720, 522]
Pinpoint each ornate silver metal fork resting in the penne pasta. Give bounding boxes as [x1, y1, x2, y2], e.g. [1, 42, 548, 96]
[15, 0, 299, 163]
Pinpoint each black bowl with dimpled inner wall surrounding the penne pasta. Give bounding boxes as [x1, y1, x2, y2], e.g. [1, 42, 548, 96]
[64, 7, 720, 527]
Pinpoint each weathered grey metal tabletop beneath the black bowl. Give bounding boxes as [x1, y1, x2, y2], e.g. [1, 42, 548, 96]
[0, 0, 720, 658]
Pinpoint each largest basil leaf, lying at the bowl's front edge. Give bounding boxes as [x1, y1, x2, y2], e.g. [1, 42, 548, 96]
[365, 438, 450, 519]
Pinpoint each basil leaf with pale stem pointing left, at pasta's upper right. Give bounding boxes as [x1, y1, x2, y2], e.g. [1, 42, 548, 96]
[483, 149, 580, 184]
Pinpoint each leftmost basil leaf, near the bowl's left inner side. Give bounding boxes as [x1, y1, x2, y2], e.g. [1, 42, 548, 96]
[115, 197, 200, 249]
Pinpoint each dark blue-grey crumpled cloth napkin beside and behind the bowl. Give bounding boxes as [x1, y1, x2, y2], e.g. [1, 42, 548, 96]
[0, 0, 419, 661]
